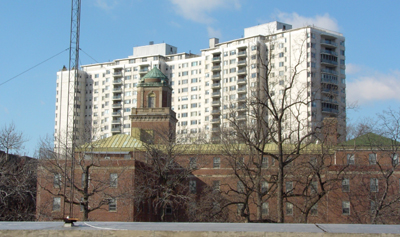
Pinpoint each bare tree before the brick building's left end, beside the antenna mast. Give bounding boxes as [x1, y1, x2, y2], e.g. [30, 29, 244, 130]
[38, 130, 133, 220]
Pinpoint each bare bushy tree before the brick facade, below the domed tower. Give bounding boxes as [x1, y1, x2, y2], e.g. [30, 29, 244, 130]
[134, 129, 208, 221]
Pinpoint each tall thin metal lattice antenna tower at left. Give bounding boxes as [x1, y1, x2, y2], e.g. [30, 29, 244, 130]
[63, 0, 81, 217]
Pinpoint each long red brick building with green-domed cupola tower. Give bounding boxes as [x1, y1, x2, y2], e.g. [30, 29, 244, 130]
[37, 68, 400, 223]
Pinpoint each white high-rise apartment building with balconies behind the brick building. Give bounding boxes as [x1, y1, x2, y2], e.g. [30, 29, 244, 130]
[55, 22, 346, 146]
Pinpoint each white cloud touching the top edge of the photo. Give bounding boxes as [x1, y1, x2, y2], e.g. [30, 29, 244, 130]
[170, 0, 241, 24]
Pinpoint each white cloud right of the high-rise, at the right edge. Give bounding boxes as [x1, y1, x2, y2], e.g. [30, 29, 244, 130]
[346, 70, 400, 104]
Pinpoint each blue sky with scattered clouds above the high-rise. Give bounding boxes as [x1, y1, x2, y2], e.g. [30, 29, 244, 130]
[0, 0, 400, 155]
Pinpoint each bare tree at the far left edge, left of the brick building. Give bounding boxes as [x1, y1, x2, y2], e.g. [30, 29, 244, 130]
[0, 123, 37, 221]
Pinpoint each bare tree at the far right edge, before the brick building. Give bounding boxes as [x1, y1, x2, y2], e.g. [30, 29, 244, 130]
[342, 109, 400, 224]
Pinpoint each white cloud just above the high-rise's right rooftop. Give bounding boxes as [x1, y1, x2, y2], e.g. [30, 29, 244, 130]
[273, 11, 339, 31]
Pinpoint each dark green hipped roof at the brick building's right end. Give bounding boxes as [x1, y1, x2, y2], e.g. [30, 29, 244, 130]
[340, 132, 400, 147]
